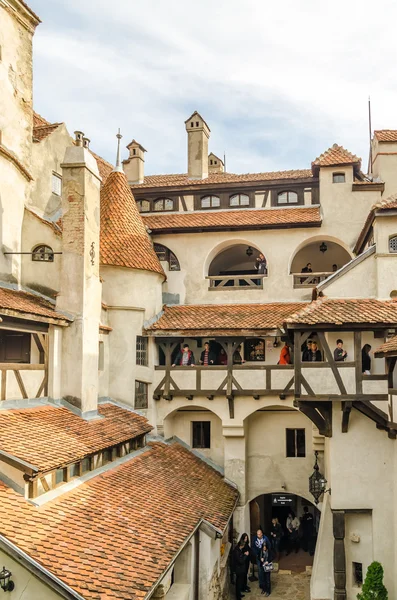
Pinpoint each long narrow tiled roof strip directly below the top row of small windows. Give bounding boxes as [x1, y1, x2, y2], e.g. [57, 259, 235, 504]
[142, 207, 322, 233]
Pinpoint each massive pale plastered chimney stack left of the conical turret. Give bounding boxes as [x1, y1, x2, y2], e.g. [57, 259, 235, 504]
[56, 139, 101, 418]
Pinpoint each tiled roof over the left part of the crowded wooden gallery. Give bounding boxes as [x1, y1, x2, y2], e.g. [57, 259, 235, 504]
[146, 302, 305, 335]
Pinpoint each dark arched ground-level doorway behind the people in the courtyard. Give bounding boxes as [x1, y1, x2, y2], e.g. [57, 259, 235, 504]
[250, 492, 321, 573]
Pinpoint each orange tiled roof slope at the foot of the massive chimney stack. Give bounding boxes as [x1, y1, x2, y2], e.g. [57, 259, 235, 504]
[0, 403, 153, 472]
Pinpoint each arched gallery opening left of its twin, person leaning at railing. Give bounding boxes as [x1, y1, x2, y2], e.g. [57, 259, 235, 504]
[208, 243, 268, 289]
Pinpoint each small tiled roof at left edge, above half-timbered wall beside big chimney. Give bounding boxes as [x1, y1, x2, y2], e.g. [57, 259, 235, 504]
[0, 287, 71, 323]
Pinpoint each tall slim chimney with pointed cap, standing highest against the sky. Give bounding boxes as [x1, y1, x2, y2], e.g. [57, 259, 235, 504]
[185, 111, 210, 179]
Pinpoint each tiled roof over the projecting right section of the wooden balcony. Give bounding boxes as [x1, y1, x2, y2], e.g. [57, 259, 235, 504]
[286, 298, 397, 325]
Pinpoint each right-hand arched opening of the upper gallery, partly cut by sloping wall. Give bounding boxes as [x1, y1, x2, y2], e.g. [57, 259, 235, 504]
[290, 238, 351, 288]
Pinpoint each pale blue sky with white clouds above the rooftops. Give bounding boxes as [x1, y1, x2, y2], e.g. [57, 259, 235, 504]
[28, 0, 397, 174]
